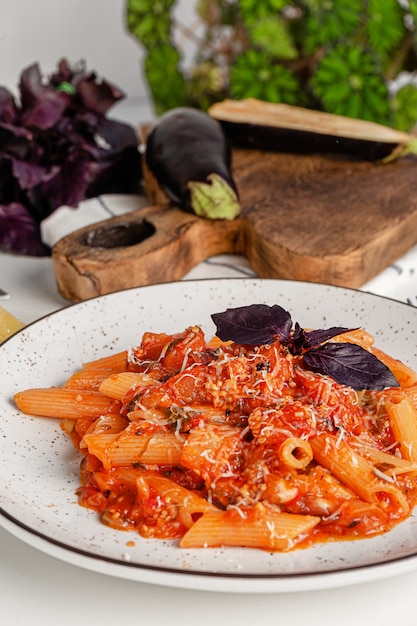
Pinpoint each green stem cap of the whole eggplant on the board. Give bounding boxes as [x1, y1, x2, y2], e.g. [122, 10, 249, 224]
[187, 174, 240, 220]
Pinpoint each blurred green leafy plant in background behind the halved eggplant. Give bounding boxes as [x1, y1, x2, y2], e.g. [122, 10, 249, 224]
[126, 0, 417, 130]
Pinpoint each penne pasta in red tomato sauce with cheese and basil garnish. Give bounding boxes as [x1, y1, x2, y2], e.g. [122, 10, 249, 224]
[15, 305, 417, 552]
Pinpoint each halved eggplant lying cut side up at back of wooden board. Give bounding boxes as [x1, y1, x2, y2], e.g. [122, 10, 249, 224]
[208, 98, 417, 161]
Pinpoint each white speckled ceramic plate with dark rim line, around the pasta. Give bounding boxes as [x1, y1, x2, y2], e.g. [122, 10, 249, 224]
[0, 279, 417, 593]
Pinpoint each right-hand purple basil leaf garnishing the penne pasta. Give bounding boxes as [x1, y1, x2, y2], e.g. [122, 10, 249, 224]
[304, 343, 399, 391]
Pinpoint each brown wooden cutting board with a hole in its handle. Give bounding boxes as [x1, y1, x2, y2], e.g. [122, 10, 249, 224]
[52, 150, 417, 301]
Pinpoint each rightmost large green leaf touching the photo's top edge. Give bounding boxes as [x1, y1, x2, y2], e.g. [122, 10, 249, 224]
[366, 0, 406, 55]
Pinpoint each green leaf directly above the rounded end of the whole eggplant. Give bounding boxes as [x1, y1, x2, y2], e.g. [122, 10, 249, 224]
[144, 44, 187, 115]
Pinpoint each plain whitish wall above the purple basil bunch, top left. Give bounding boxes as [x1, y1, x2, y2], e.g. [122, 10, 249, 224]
[0, 0, 195, 109]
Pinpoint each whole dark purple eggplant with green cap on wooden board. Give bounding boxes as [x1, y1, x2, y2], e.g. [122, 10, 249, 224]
[145, 107, 240, 220]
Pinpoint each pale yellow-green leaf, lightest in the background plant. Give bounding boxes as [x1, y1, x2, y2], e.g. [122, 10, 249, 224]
[248, 17, 298, 60]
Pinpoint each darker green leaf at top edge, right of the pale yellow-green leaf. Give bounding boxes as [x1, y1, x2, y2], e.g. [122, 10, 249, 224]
[304, 0, 364, 54]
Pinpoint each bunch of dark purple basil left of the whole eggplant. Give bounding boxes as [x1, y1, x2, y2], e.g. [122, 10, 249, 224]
[0, 60, 142, 255]
